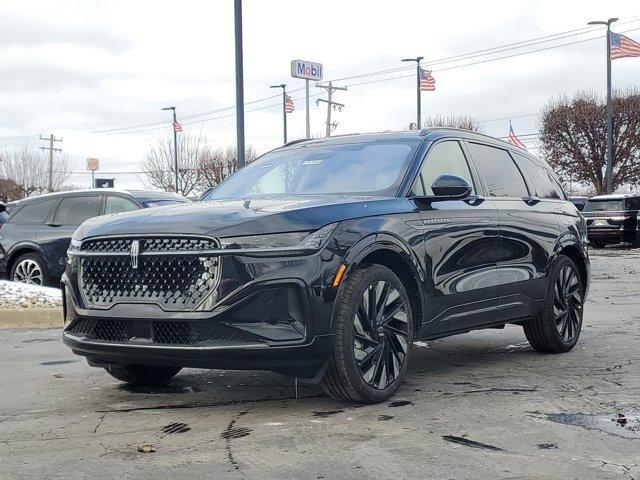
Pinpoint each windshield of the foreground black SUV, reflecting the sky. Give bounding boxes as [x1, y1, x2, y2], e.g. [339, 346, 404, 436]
[204, 141, 418, 200]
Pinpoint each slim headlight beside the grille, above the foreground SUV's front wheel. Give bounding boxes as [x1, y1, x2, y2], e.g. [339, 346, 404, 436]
[220, 223, 338, 250]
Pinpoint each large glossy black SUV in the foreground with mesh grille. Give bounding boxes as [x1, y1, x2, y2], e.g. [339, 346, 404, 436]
[63, 128, 589, 402]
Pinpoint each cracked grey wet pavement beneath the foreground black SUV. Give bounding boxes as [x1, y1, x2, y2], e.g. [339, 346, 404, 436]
[0, 249, 640, 480]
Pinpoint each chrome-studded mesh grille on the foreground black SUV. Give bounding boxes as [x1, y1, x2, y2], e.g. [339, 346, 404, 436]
[79, 237, 220, 311]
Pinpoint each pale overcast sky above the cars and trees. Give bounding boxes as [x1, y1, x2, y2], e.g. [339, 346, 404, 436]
[0, 0, 640, 188]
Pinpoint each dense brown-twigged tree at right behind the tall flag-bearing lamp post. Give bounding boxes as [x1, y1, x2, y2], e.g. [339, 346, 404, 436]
[540, 88, 640, 194]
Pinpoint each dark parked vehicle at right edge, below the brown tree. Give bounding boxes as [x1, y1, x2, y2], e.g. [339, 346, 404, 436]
[582, 195, 640, 248]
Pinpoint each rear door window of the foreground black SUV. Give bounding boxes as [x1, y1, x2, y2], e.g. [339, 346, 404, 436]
[468, 143, 528, 198]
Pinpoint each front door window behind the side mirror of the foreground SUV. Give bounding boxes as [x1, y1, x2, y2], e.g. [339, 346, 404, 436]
[412, 141, 475, 196]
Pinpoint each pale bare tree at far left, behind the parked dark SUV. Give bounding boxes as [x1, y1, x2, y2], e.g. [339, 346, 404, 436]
[0, 145, 71, 197]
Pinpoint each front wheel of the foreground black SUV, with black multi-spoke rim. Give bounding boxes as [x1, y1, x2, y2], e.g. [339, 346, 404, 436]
[322, 265, 413, 403]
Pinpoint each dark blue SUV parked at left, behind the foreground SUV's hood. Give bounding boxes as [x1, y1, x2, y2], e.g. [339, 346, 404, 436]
[0, 189, 187, 285]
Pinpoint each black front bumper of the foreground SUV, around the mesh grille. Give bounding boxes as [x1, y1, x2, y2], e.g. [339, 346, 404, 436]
[62, 240, 340, 379]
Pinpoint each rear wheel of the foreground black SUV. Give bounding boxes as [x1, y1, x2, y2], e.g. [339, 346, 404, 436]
[523, 255, 584, 353]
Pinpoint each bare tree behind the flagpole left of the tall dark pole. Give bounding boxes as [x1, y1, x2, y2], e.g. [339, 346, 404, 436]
[142, 133, 210, 196]
